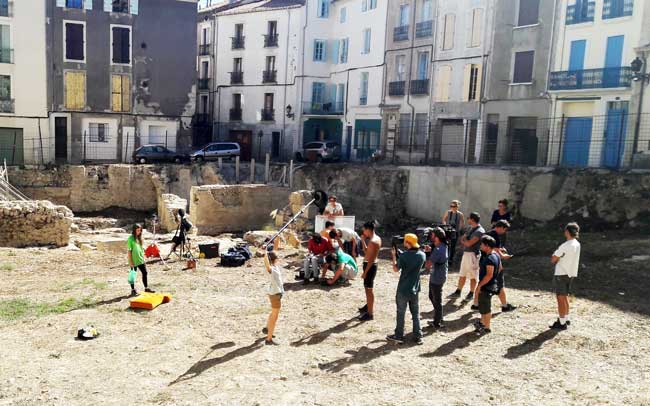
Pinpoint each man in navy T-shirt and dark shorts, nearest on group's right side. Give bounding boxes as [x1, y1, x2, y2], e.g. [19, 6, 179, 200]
[475, 235, 501, 335]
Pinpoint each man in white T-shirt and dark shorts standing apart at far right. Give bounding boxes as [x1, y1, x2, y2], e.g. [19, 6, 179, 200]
[550, 223, 580, 330]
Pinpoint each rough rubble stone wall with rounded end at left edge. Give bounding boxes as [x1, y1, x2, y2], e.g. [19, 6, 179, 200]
[0, 201, 73, 247]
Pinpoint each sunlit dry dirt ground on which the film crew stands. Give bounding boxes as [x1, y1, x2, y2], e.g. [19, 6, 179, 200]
[0, 224, 650, 406]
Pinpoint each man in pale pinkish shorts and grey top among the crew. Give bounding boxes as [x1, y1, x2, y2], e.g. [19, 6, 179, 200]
[452, 212, 485, 300]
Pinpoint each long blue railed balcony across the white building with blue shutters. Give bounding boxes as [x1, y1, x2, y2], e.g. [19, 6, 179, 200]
[549, 66, 632, 90]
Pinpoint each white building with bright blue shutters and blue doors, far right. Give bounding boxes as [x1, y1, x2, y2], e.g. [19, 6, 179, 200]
[548, 0, 650, 168]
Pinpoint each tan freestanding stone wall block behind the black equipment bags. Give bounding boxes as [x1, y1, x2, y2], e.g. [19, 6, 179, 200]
[190, 185, 289, 235]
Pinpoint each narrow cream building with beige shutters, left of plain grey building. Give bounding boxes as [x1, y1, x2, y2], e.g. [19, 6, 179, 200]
[431, 0, 495, 163]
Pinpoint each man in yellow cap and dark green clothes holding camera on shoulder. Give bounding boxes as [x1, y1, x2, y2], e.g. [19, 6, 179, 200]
[386, 234, 426, 345]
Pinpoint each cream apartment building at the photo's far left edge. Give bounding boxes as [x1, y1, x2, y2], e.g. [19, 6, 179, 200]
[0, 0, 50, 165]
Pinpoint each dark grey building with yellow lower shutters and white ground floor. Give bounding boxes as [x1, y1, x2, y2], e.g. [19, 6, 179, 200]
[47, 0, 197, 163]
